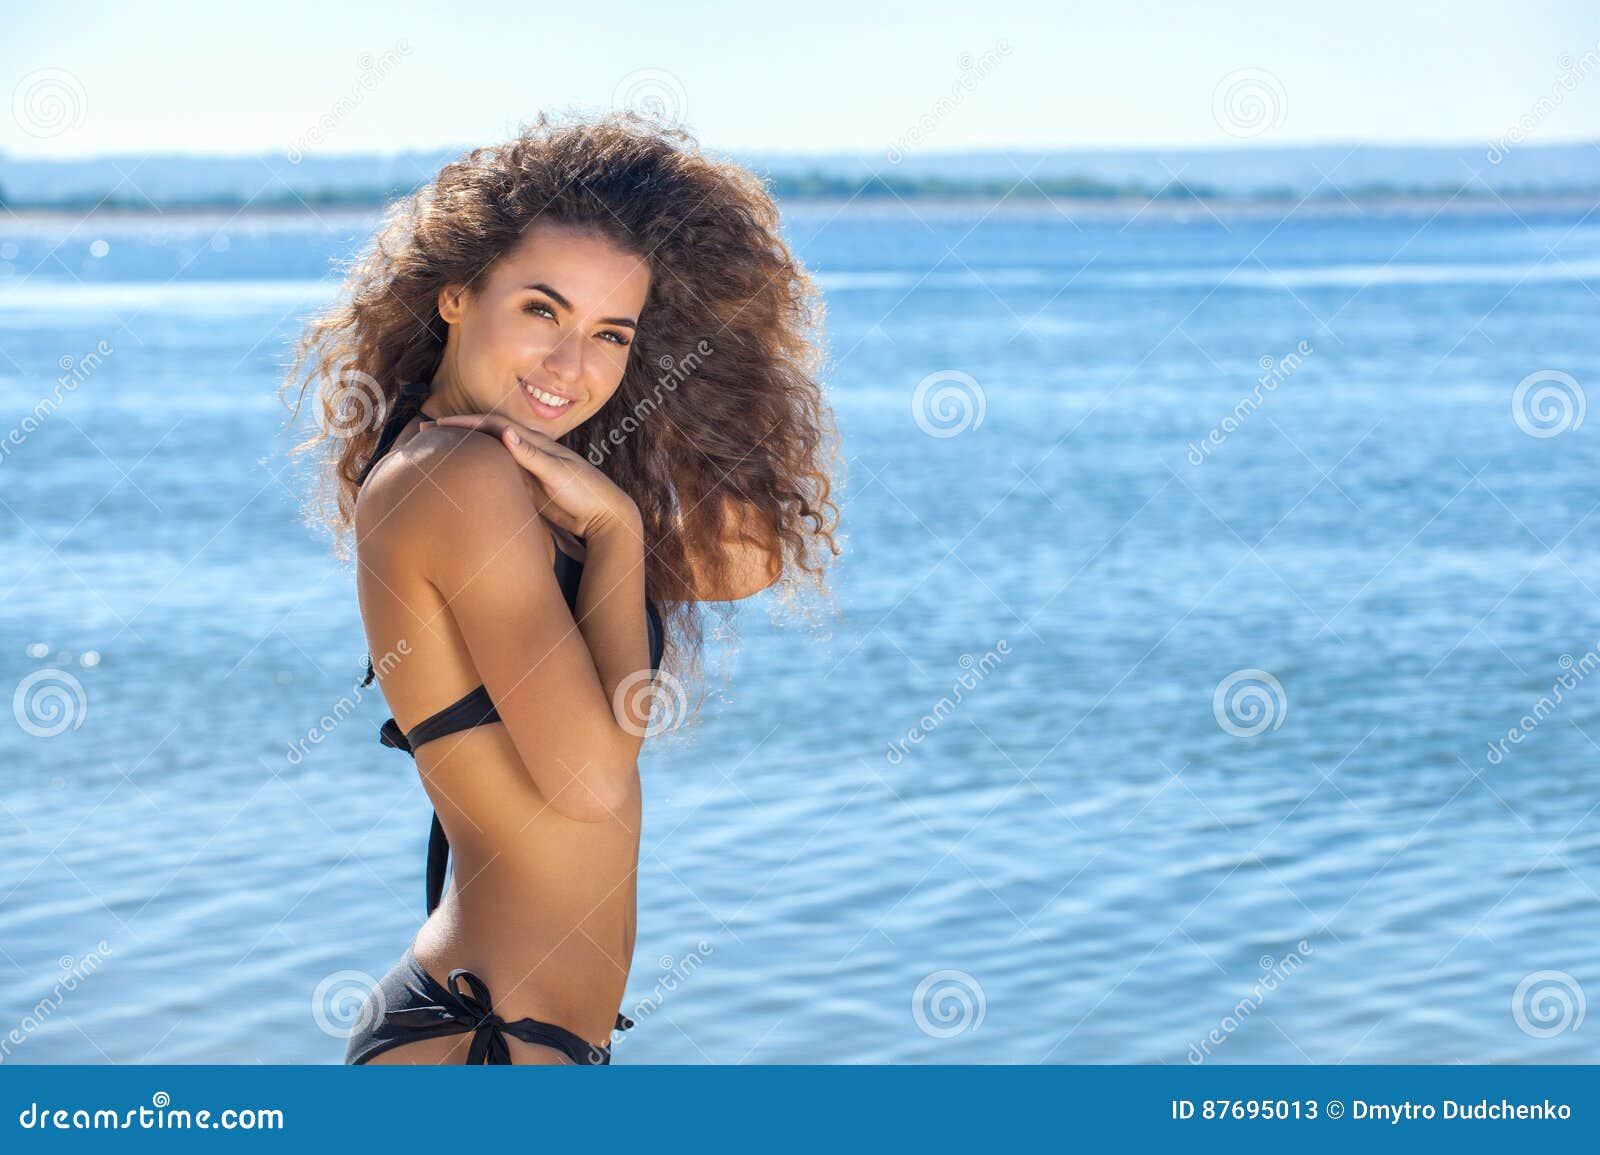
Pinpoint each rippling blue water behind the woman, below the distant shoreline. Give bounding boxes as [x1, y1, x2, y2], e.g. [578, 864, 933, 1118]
[0, 205, 1600, 1064]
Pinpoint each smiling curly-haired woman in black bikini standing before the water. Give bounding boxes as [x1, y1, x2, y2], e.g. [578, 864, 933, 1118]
[291, 114, 838, 1064]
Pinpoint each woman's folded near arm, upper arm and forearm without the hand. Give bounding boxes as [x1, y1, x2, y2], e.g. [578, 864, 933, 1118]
[413, 432, 650, 822]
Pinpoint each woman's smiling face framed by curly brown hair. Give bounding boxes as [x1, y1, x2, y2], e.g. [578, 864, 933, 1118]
[434, 222, 650, 437]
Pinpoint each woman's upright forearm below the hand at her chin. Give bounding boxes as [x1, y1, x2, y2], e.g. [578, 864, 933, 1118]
[574, 508, 650, 757]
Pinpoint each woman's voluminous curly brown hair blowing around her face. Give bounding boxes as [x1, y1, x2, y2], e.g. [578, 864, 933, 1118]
[285, 110, 840, 694]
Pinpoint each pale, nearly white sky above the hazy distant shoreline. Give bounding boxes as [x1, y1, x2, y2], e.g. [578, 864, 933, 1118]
[0, 0, 1600, 155]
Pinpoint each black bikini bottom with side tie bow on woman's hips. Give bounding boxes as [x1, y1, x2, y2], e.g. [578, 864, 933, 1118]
[344, 947, 634, 1065]
